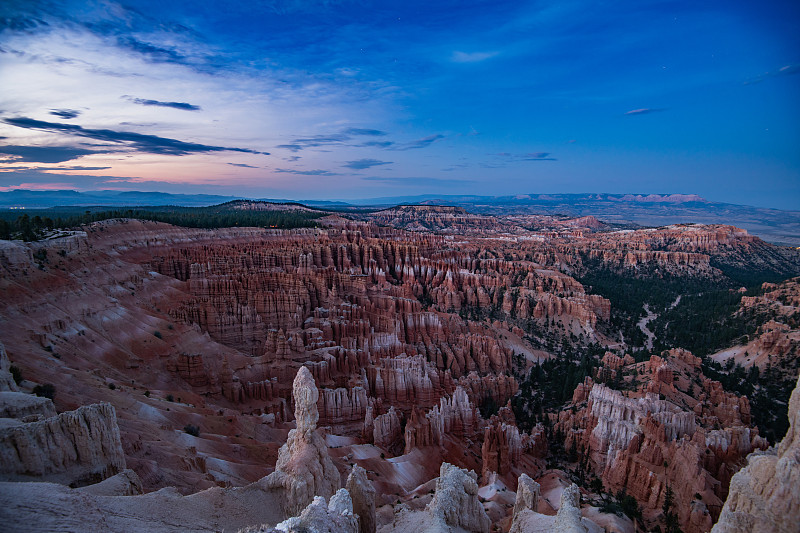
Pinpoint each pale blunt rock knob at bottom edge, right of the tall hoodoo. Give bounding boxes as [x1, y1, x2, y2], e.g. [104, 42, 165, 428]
[426, 463, 491, 532]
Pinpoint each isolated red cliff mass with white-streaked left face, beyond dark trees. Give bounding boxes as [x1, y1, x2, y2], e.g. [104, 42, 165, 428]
[558, 350, 768, 532]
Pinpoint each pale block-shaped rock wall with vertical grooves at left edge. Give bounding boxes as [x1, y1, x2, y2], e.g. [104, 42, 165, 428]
[0, 403, 125, 486]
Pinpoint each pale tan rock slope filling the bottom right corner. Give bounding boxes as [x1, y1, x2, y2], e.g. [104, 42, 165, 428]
[711, 370, 800, 533]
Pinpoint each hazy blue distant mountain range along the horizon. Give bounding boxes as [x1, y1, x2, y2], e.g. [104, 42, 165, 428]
[0, 189, 800, 246]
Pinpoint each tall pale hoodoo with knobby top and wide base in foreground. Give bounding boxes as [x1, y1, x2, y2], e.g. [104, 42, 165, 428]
[265, 366, 341, 516]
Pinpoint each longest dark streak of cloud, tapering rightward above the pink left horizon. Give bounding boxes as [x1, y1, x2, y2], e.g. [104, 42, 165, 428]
[3, 117, 269, 155]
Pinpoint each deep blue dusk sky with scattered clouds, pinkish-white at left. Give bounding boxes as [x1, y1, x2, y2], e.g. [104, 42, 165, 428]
[0, 0, 800, 210]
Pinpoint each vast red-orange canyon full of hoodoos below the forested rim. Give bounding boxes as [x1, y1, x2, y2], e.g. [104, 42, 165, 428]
[0, 203, 800, 533]
